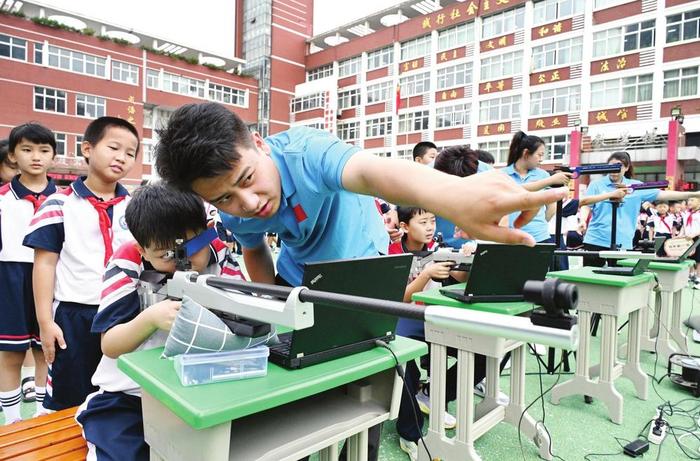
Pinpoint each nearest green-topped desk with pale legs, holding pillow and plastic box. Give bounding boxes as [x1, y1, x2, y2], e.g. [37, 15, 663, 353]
[118, 337, 427, 461]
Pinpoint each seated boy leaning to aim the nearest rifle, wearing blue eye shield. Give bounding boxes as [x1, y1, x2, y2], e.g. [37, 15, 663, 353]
[76, 184, 243, 460]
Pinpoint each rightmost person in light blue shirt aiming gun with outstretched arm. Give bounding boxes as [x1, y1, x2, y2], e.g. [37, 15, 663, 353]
[581, 152, 700, 266]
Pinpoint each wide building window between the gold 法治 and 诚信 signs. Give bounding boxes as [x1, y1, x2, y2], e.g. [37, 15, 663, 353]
[591, 74, 652, 109]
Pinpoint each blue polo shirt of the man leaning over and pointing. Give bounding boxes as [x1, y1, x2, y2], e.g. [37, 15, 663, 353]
[221, 127, 389, 285]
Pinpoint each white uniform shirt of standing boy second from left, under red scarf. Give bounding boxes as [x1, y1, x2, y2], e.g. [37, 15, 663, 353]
[24, 178, 133, 309]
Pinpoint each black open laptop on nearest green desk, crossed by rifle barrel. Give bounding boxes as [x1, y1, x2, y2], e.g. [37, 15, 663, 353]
[269, 254, 413, 369]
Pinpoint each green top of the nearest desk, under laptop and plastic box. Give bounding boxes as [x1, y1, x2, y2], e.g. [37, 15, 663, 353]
[118, 336, 428, 429]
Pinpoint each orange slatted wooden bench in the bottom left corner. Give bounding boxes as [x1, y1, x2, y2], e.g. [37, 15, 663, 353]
[0, 407, 87, 461]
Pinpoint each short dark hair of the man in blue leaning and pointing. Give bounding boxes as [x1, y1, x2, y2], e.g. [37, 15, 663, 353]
[156, 102, 253, 189]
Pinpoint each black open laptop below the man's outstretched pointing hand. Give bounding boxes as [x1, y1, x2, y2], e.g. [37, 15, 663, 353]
[440, 243, 555, 303]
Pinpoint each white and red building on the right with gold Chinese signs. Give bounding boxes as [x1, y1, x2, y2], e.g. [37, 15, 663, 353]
[290, 0, 700, 187]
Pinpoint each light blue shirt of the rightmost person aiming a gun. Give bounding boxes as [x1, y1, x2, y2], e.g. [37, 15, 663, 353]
[583, 175, 661, 250]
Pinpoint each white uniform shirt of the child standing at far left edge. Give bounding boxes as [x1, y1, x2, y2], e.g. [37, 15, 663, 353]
[0, 176, 56, 263]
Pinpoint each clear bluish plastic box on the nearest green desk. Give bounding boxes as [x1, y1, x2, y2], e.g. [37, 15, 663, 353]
[174, 346, 270, 386]
